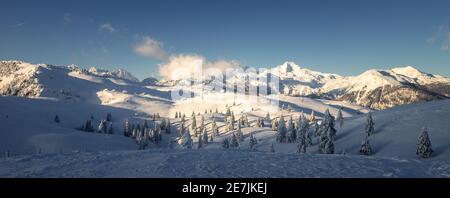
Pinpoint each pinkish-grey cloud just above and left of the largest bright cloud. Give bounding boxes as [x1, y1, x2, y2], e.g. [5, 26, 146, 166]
[134, 36, 168, 60]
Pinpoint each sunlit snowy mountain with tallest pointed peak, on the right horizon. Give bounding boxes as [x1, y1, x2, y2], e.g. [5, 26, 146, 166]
[270, 62, 450, 109]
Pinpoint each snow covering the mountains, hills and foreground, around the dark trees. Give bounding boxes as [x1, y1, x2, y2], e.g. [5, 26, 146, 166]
[0, 61, 450, 177]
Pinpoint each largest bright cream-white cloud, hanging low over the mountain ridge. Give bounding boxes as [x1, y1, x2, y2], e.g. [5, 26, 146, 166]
[159, 54, 239, 80]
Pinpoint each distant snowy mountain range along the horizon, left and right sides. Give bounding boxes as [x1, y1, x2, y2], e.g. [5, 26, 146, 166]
[0, 61, 450, 109]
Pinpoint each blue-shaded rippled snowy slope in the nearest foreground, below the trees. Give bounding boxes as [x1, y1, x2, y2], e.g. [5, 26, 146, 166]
[0, 149, 450, 178]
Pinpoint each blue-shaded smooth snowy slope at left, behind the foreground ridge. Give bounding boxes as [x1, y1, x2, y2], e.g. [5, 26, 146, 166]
[0, 97, 137, 155]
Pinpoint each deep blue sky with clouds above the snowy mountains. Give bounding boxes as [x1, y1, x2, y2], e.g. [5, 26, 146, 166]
[0, 0, 450, 79]
